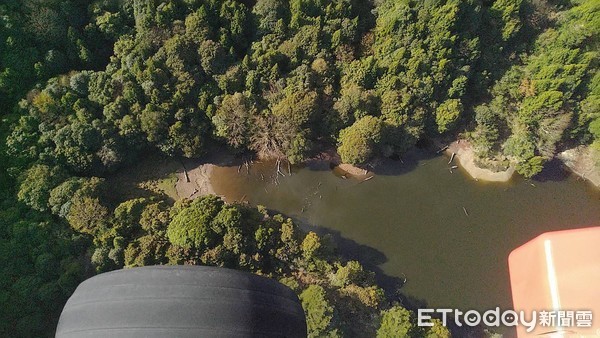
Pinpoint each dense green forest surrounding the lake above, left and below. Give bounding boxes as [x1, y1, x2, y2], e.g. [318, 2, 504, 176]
[0, 0, 600, 337]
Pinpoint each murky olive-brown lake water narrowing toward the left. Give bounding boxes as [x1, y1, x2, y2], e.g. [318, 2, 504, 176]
[211, 150, 600, 310]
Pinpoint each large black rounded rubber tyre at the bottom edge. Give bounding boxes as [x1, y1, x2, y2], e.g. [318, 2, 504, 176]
[56, 266, 306, 338]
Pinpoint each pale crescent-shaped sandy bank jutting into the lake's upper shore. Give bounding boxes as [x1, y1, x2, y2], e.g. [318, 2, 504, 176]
[446, 140, 515, 182]
